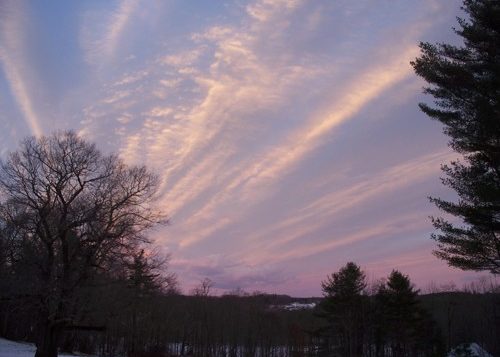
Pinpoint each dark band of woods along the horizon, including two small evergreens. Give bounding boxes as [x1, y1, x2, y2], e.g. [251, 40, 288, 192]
[0, 254, 500, 357]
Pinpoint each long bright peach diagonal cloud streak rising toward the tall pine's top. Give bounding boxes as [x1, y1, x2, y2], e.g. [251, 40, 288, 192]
[172, 41, 426, 246]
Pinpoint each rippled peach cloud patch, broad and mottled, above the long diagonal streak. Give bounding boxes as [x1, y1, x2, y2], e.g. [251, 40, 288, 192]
[84, 2, 324, 212]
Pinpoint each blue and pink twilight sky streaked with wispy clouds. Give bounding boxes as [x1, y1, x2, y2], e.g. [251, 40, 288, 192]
[0, 0, 492, 296]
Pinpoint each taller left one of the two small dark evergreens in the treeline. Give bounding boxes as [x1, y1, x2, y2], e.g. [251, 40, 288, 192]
[320, 262, 366, 356]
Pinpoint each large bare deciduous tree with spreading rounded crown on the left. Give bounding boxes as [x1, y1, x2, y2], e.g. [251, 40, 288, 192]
[0, 131, 163, 357]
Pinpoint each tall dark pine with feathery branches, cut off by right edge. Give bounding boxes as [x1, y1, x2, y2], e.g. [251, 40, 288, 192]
[412, 0, 500, 274]
